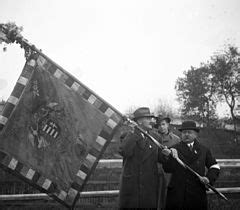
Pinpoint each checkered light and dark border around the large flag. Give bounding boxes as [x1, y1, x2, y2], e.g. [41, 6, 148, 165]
[0, 54, 122, 208]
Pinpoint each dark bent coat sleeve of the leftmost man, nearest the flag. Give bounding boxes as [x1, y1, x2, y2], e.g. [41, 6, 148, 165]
[119, 132, 139, 157]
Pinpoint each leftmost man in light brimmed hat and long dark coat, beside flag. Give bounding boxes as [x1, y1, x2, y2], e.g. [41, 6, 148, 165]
[119, 107, 163, 209]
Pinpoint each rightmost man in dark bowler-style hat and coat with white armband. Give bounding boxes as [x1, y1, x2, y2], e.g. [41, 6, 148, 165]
[162, 121, 220, 210]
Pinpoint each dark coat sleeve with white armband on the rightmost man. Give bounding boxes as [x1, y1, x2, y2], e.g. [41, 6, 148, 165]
[206, 150, 220, 185]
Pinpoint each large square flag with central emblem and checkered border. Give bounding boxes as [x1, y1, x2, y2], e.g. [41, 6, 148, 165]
[0, 54, 122, 207]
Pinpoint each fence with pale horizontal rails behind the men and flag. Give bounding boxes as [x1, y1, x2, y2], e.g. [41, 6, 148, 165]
[0, 159, 240, 210]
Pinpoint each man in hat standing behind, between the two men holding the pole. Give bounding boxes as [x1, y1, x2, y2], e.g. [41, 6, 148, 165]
[154, 115, 180, 210]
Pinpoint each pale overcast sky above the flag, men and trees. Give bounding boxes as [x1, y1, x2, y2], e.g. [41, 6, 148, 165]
[0, 0, 240, 115]
